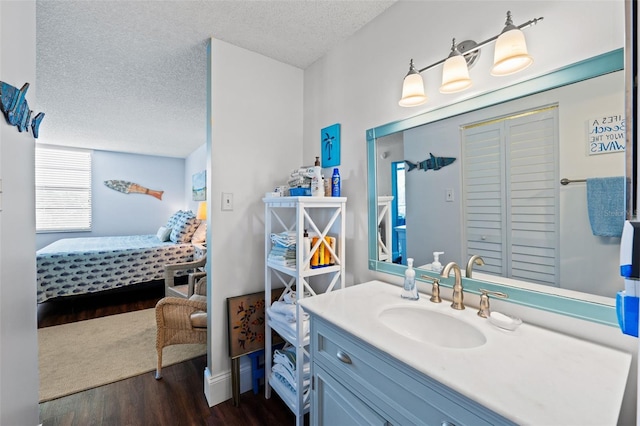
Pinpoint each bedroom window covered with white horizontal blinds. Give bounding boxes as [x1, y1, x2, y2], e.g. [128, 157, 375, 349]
[36, 146, 91, 232]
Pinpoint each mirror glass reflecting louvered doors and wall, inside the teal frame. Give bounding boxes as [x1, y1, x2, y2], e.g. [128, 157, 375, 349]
[376, 67, 625, 297]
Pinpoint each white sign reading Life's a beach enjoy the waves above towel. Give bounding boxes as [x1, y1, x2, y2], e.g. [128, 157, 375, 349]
[587, 114, 626, 155]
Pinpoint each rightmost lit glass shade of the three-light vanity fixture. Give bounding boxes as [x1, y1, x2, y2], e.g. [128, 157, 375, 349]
[491, 29, 533, 76]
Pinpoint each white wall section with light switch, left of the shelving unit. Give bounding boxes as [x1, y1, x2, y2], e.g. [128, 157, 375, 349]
[205, 39, 304, 405]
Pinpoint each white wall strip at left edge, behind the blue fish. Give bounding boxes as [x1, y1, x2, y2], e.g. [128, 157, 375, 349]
[0, 1, 40, 425]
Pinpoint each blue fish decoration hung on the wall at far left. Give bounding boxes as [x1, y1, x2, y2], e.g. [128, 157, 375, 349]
[0, 81, 44, 139]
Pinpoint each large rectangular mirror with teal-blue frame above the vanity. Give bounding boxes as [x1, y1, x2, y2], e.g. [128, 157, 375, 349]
[366, 49, 633, 325]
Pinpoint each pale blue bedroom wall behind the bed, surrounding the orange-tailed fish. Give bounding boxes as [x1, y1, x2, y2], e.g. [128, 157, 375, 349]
[36, 151, 185, 249]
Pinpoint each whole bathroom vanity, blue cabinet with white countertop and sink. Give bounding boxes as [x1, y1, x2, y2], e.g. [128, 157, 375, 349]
[298, 281, 631, 426]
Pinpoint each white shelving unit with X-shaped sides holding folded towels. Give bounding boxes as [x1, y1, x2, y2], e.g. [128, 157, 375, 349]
[263, 197, 347, 426]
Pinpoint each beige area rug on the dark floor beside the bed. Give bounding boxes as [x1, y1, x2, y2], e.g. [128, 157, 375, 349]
[38, 309, 206, 402]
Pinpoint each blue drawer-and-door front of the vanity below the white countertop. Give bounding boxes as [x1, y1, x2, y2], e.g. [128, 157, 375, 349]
[311, 314, 515, 426]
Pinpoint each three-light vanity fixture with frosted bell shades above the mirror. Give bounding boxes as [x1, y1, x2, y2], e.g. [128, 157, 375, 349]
[398, 11, 544, 107]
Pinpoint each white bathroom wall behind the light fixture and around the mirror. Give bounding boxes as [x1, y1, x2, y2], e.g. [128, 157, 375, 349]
[303, 0, 637, 424]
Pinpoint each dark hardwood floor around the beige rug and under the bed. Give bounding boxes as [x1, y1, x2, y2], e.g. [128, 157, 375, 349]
[38, 282, 298, 426]
